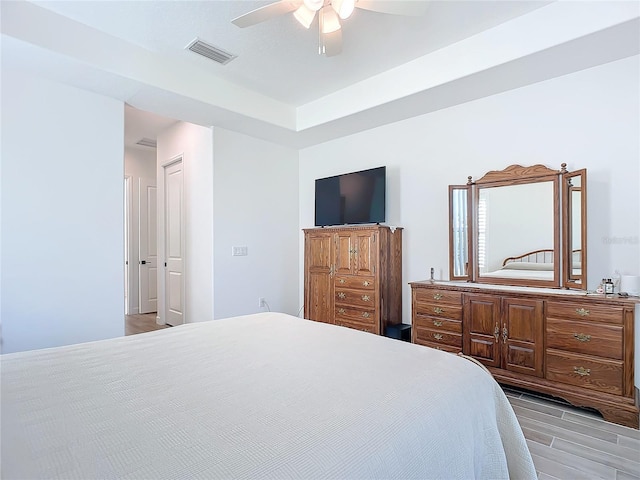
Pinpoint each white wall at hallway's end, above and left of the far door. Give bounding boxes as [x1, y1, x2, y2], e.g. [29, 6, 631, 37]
[124, 148, 156, 314]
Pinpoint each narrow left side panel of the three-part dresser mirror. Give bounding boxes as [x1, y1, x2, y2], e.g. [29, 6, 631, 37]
[449, 185, 471, 280]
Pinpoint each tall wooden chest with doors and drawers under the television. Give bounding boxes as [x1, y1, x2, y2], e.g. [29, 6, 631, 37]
[304, 225, 402, 335]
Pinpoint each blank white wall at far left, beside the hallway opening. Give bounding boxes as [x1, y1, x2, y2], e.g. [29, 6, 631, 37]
[1, 69, 124, 353]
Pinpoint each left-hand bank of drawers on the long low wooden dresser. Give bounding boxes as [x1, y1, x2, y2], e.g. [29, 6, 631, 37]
[412, 290, 462, 353]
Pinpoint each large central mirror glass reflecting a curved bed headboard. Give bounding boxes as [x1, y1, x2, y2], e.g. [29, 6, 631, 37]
[476, 181, 558, 283]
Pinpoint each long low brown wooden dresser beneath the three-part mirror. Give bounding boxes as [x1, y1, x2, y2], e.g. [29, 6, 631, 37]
[411, 282, 640, 428]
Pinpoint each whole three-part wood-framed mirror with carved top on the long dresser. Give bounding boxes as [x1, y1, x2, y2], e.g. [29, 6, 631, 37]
[449, 164, 586, 288]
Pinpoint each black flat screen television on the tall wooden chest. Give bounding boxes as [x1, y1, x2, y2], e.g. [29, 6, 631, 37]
[315, 167, 386, 227]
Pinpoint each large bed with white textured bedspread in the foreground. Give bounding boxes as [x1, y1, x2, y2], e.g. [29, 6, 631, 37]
[1, 313, 535, 479]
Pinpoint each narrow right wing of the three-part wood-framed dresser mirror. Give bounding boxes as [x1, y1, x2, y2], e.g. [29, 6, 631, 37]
[562, 169, 587, 289]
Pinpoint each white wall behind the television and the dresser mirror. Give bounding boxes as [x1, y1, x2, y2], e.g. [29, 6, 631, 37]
[299, 56, 640, 323]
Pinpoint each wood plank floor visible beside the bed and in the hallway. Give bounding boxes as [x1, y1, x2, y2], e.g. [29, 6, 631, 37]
[125, 313, 640, 480]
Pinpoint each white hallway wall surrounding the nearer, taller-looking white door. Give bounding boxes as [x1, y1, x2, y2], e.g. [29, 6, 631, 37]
[156, 122, 213, 323]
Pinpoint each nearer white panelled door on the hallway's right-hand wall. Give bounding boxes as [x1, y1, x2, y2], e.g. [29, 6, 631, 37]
[164, 159, 184, 326]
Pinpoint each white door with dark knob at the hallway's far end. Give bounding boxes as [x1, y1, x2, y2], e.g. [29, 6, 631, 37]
[138, 178, 158, 313]
